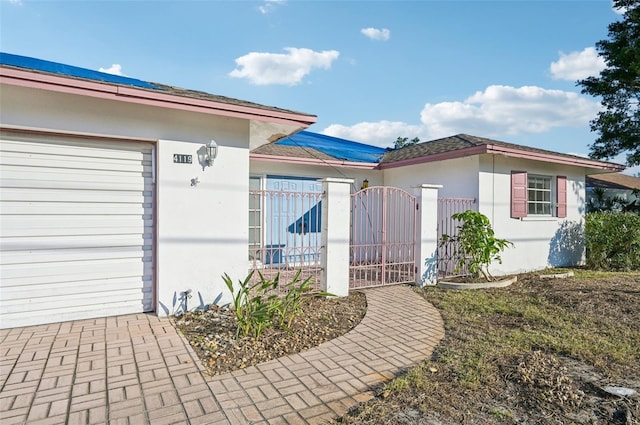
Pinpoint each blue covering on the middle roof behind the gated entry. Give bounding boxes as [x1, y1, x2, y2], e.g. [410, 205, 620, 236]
[275, 131, 387, 163]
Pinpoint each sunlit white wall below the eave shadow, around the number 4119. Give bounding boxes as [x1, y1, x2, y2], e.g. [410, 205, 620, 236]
[157, 140, 249, 314]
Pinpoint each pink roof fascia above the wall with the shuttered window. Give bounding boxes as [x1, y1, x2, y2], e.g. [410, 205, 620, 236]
[379, 144, 626, 173]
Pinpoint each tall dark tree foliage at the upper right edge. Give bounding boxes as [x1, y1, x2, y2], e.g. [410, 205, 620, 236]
[578, 0, 640, 166]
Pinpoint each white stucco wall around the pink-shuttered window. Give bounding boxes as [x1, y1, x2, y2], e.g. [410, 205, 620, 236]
[384, 155, 585, 275]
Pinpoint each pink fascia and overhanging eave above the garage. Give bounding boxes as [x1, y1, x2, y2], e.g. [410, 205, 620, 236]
[0, 66, 317, 149]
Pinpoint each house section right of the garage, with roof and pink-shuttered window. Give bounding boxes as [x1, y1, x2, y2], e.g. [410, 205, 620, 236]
[250, 131, 624, 275]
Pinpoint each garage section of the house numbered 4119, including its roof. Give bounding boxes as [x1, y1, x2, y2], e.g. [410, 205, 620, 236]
[0, 53, 316, 328]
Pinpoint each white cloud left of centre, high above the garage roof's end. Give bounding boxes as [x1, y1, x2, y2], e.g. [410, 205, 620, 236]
[229, 47, 340, 86]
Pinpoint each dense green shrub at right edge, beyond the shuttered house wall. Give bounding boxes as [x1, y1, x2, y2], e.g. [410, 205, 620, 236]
[585, 211, 640, 271]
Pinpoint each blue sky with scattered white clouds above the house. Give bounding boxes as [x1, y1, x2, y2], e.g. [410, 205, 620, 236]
[0, 0, 640, 173]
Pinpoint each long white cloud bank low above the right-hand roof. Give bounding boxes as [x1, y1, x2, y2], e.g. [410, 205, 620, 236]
[323, 85, 600, 146]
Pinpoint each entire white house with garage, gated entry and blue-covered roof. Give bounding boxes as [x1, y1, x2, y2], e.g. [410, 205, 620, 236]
[0, 53, 624, 328]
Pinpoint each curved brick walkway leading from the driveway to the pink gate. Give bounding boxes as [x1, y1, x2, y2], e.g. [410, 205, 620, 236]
[209, 286, 444, 424]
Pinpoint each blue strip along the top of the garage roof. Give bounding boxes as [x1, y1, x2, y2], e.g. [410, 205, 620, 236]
[0, 52, 158, 89]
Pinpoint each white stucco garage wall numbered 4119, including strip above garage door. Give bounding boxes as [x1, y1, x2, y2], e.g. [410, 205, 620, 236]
[1, 85, 250, 315]
